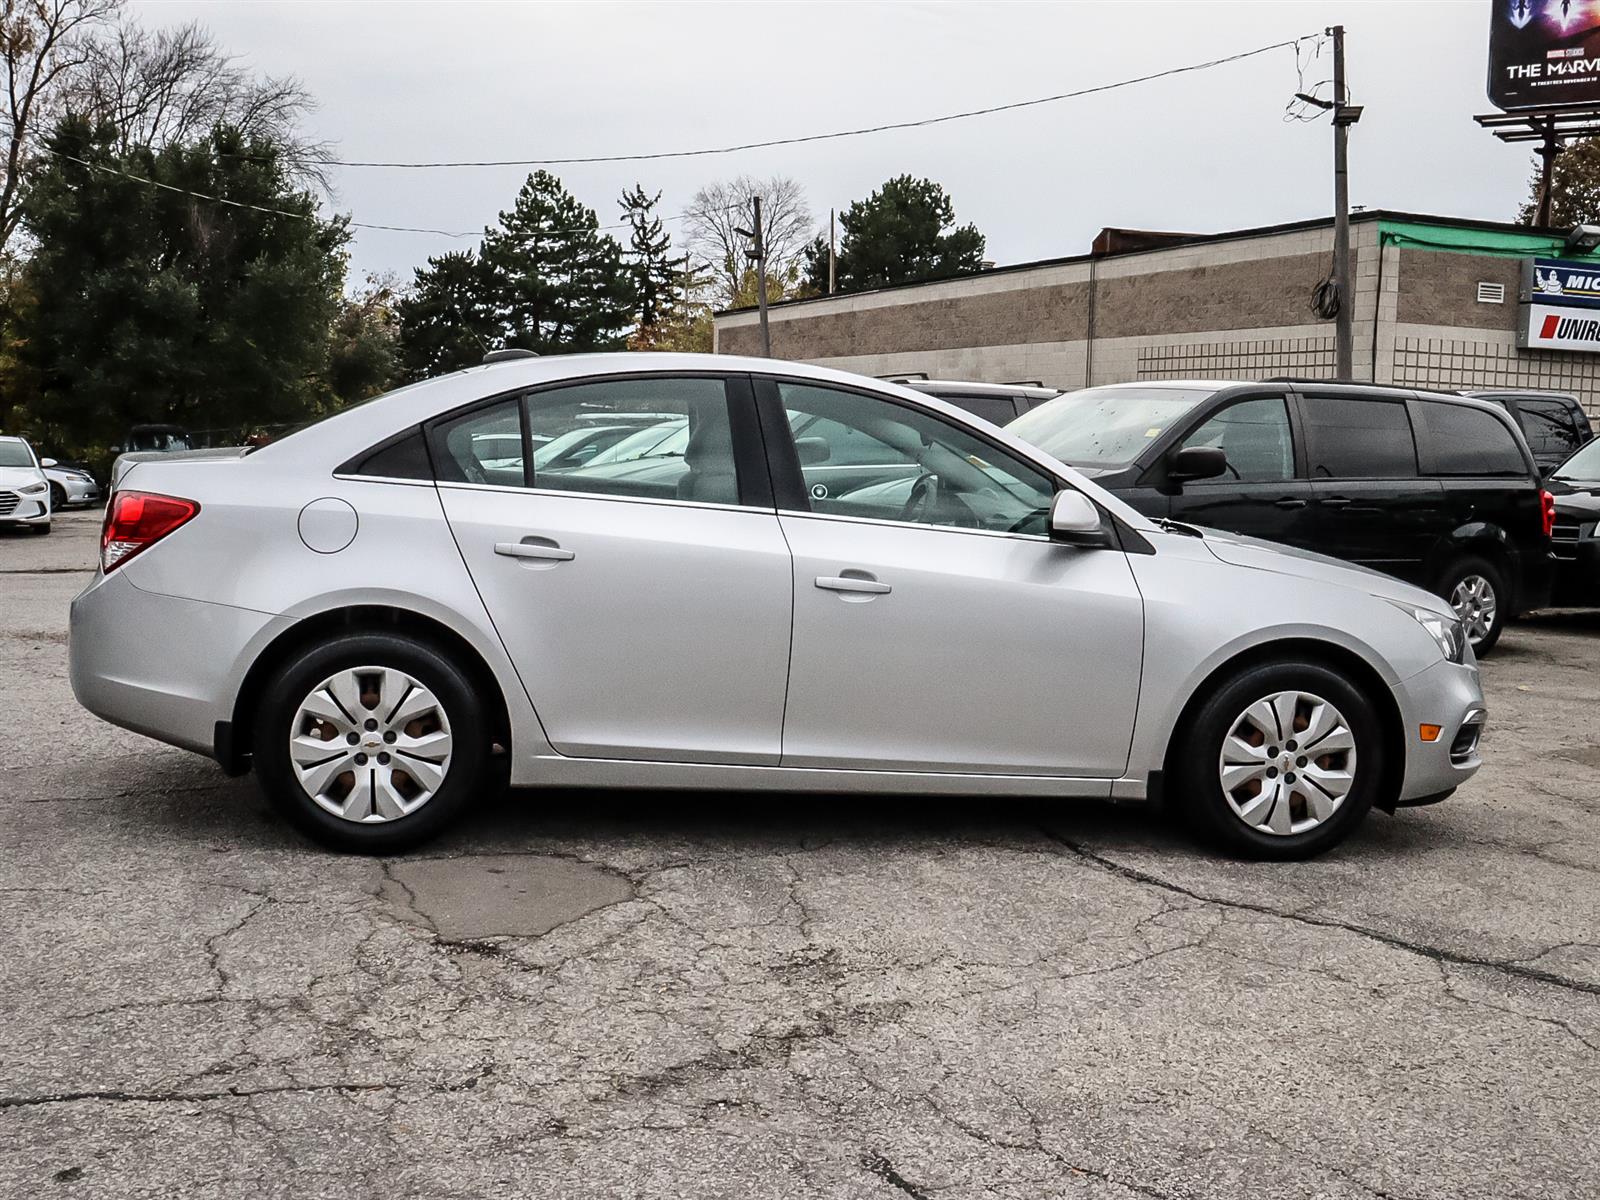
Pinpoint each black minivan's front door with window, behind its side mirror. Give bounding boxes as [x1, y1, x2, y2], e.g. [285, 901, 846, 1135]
[1168, 392, 1315, 549]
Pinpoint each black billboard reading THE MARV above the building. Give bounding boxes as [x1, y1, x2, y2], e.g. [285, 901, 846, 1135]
[1490, 0, 1600, 112]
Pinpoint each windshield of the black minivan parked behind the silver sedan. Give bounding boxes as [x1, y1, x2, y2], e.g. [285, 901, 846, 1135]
[1006, 387, 1211, 467]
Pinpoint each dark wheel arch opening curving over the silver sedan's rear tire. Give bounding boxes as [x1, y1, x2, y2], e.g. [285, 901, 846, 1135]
[225, 605, 512, 774]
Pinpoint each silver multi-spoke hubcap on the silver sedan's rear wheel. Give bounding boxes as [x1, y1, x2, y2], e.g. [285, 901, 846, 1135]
[290, 667, 451, 824]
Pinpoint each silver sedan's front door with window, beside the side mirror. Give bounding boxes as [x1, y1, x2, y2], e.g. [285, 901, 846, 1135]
[757, 382, 1144, 779]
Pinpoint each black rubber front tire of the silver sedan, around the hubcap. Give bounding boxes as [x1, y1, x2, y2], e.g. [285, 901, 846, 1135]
[1168, 661, 1386, 861]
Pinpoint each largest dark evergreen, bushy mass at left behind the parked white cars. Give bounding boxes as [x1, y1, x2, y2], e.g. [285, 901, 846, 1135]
[11, 118, 349, 453]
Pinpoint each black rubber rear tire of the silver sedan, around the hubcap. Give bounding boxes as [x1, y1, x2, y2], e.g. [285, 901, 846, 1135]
[251, 634, 494, 854]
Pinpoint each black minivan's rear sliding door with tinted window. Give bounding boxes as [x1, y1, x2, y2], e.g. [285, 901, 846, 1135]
[1296, 387, 1446, 584]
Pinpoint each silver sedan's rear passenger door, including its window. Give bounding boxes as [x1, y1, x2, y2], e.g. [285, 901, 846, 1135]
[430, 378, 790, 765]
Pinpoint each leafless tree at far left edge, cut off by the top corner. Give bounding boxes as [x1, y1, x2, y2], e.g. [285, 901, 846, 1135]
[0, 0, 122, 253]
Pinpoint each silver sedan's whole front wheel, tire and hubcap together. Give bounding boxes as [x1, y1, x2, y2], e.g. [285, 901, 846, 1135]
[1173, 661, 1384, 859]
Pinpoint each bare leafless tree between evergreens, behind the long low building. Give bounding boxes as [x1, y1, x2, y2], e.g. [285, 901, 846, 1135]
[683, 174, 814, 307]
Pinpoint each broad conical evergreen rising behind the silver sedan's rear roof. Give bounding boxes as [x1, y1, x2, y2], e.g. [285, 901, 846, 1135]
[482, 171, 634, 354]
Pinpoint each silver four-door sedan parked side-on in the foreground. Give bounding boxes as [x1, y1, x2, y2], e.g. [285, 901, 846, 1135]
[72, 354, 1486, 858]
